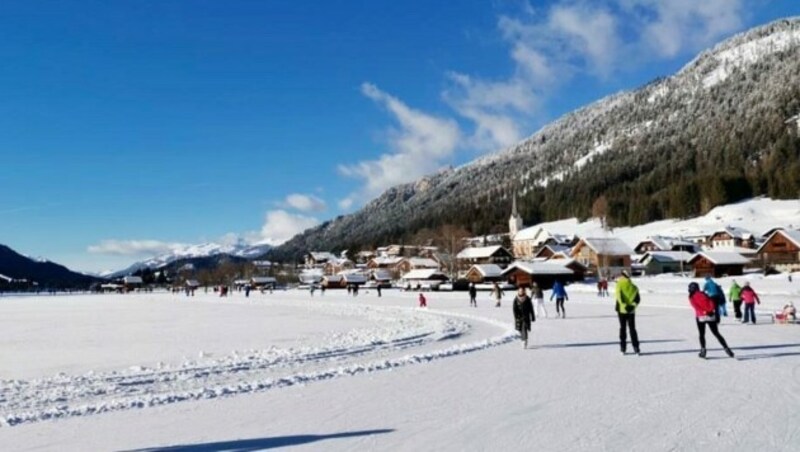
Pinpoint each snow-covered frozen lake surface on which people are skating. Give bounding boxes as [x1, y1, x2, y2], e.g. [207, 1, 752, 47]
[0, 275, 800, 450]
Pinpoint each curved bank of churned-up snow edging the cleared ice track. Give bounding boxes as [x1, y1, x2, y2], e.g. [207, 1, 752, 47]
[0, 305, 518, 427]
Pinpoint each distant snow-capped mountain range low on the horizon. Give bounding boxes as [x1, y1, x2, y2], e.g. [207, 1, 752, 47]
[106, 240, 272, 279]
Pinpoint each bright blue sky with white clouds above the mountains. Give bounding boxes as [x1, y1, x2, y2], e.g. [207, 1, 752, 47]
[0, 0, 800, 271]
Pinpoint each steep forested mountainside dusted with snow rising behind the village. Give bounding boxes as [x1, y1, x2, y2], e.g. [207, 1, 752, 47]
[270, 18, 800, 260]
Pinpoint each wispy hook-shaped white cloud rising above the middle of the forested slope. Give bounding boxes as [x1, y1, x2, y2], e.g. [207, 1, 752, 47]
[338, 83, 461, 198]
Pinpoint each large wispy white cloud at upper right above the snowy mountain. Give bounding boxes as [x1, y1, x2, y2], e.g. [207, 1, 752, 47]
[443, 0, 744, 151]
